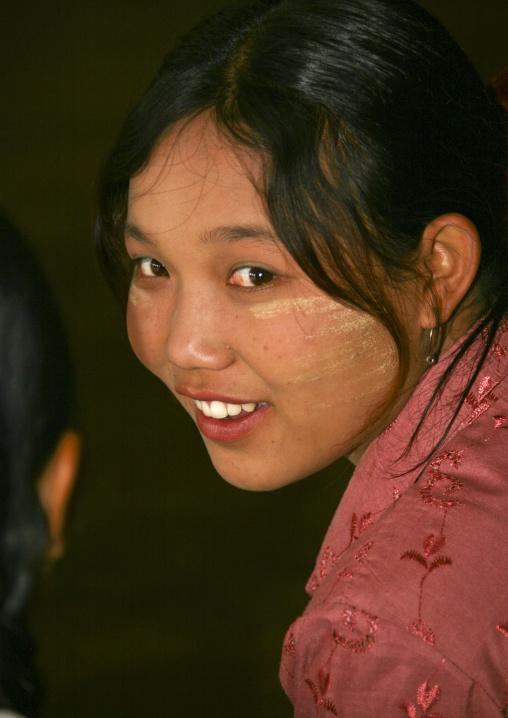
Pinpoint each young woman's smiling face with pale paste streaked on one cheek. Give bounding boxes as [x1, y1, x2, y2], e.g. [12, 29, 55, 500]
[125, 118, 408, 489]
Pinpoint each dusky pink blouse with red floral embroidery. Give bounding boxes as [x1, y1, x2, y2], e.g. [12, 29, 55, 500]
[280, 322, 508, 718]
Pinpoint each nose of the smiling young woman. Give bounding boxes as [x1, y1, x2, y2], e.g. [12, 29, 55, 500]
[166, 291, 234, 371]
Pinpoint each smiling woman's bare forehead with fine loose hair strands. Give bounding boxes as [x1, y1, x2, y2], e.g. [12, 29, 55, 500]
[128, 117, 265, 231]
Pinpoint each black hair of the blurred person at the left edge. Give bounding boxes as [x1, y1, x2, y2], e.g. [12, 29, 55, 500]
[0, 216, 74, 716]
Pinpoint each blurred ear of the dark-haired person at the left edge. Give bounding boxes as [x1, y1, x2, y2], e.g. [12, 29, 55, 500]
[37, 431, 81, 559]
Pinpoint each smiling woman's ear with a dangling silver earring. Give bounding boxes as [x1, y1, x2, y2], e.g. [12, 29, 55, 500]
[420, 214, 481, 329]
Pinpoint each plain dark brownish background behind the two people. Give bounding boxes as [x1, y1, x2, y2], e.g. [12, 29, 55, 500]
[0, 0, 508, 718]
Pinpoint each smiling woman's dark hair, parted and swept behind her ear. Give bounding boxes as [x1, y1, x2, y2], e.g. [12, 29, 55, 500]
[96, 0, 508, 444]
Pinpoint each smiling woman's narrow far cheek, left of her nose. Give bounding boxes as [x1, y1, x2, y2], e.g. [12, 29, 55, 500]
[126, 289, 165, 372]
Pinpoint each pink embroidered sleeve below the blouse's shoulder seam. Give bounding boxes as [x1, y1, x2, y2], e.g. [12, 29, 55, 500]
[281, 605, 502, 718]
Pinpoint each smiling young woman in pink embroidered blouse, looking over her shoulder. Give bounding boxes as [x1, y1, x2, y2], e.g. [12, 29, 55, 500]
[97, 0, 508, 718]
